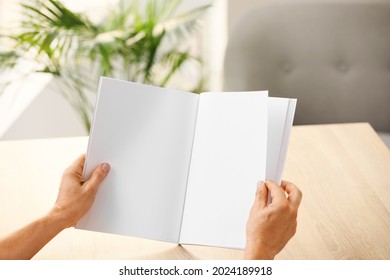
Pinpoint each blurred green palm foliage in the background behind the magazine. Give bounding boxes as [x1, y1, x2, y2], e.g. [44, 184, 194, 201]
[0, 0, 208, 129]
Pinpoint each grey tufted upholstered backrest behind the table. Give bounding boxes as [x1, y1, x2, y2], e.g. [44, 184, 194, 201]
[224, 0, 390, 131]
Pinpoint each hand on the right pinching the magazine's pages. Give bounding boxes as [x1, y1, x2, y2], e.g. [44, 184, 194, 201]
[244, 181, 302, 259]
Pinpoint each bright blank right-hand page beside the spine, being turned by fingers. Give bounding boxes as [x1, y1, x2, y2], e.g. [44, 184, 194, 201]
[180, 92, 268, 248]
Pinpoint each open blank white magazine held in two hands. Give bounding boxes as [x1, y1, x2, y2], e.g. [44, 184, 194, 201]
[77, 78, 296, 248]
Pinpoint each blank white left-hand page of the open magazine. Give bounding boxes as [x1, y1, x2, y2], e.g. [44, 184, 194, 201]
[77, 78, 199, 243]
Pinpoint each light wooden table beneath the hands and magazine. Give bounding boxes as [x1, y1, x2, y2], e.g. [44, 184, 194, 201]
[0, 124, 390, 259]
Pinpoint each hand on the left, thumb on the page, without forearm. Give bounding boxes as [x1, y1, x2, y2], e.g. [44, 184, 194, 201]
[50, 155, 110, 228]
